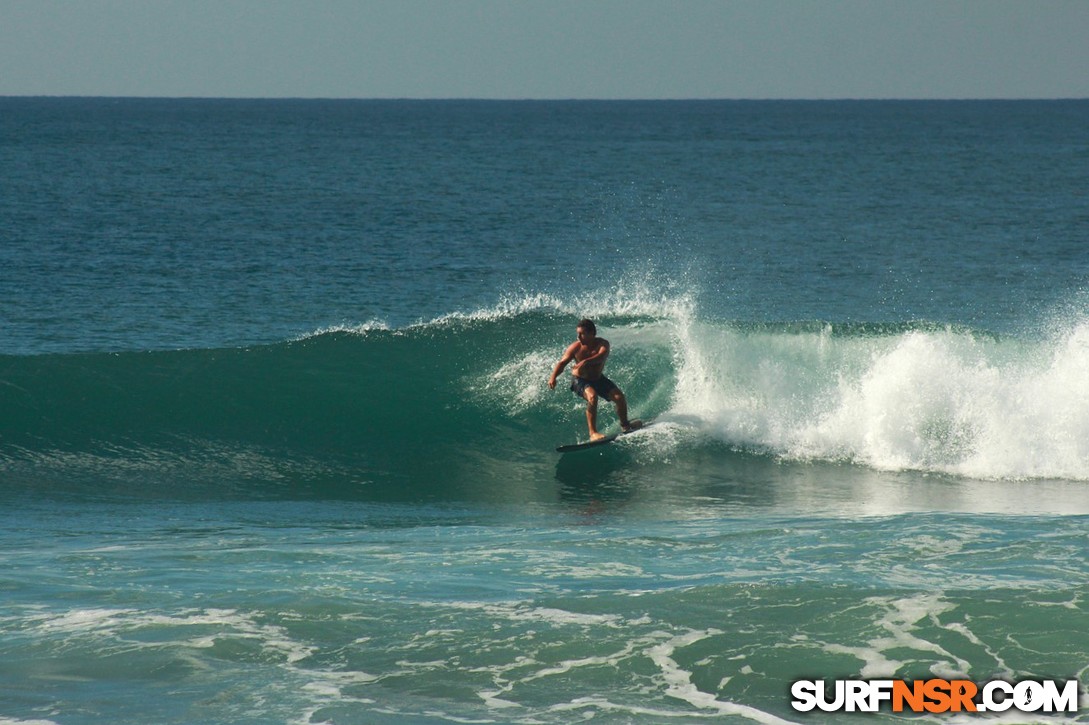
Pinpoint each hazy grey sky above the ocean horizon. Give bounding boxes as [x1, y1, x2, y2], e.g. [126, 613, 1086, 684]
[0, 0, 1089, 98]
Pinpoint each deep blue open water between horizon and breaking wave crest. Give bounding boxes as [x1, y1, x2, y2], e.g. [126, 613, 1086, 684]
[8, 99, 1089, 354]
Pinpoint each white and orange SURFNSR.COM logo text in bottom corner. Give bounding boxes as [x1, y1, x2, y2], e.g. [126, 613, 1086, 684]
[791, 679, 1079, 713]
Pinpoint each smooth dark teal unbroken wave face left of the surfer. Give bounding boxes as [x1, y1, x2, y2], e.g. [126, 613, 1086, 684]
[0, 314, 668, 499]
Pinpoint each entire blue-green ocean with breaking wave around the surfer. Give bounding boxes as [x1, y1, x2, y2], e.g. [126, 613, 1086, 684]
[0, 98, 1089, 725]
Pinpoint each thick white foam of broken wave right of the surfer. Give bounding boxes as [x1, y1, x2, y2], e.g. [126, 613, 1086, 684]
[671, 322, 1089, 480]
